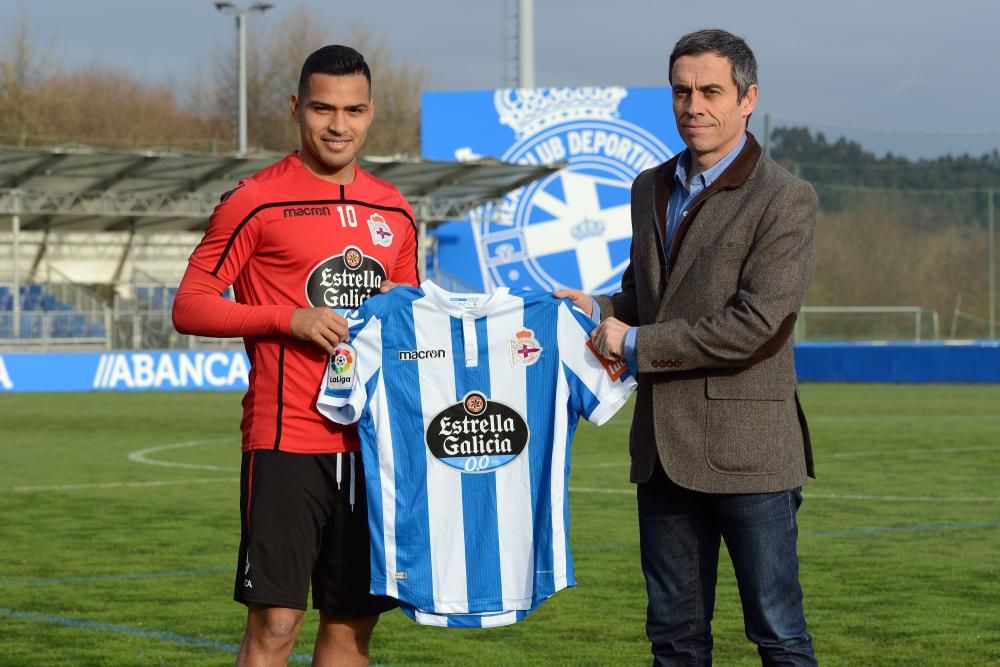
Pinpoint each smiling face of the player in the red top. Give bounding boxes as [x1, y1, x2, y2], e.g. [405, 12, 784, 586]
[289, 74, 375, 184]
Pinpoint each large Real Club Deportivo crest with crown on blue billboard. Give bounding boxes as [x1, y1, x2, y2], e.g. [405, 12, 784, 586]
[470, 87, 673, 294]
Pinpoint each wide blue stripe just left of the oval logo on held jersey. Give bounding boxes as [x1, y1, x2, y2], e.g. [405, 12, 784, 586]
[380, 304, 434, 600]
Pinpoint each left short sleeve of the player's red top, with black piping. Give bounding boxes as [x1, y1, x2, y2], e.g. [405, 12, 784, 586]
[189, 180, 261, 285]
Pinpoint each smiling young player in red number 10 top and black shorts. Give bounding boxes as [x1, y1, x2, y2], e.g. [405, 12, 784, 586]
[173, 46, 418, 665]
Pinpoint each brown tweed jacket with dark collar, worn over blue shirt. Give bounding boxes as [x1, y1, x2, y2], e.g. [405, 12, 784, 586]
[597, 135, 816, 493]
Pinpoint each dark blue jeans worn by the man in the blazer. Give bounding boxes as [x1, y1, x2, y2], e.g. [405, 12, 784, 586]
[637, 465, 818, 666]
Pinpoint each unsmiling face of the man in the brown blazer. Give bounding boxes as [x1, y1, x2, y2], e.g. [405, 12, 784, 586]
[671, 53, 757, 169]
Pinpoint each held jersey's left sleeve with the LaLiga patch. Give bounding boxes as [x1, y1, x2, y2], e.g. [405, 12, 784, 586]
[316, 317, 382, 424]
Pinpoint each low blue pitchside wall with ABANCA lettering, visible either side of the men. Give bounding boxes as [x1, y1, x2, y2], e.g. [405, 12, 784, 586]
[0, 341, 1000, 393]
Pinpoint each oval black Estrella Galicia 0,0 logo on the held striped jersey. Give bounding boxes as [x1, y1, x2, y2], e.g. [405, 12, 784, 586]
[426, 391, 530, 473]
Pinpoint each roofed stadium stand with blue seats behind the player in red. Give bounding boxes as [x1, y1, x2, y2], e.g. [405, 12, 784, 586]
[0, 146, 562, 351]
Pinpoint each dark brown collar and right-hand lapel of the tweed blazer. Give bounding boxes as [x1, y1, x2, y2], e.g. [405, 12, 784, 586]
[657, 132, 761, 310]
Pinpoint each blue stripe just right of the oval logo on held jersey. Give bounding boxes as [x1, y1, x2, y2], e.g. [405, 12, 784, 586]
[524, 299, 563, 603]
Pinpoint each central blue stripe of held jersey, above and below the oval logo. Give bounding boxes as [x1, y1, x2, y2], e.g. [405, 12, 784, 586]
[451, 317, 503, 612]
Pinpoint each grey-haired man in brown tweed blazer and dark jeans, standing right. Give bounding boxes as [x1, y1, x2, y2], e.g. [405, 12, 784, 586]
[556, 30, 817, 665]
